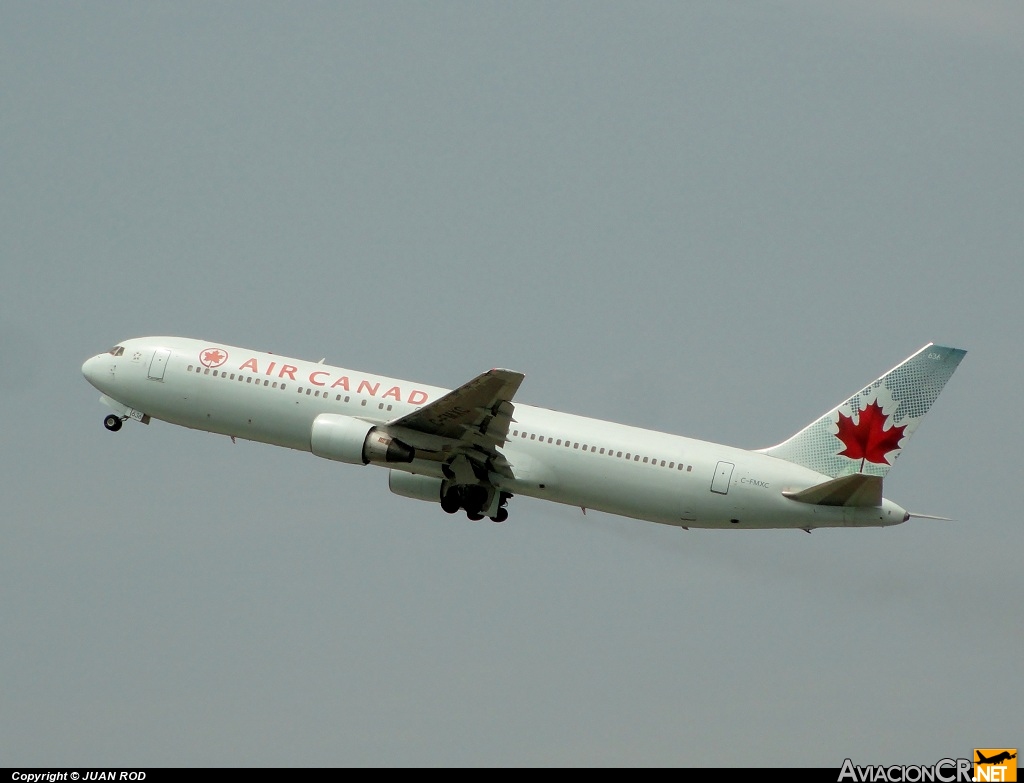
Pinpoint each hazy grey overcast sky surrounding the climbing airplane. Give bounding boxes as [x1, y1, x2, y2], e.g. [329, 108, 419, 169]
[0, 0, 1024, 769]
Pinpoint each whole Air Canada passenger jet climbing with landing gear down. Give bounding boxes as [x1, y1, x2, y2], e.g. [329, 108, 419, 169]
[82, 337, 966, 532]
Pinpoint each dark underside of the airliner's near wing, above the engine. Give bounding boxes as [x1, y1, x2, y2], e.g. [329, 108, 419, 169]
[388, 369, 525, 475]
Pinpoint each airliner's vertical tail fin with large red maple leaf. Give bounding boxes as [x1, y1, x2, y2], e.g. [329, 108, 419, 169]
[761, 343, 967, 478]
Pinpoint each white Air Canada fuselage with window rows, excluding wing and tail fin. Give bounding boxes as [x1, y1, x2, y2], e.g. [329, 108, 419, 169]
[82, 337, 905, 529]
